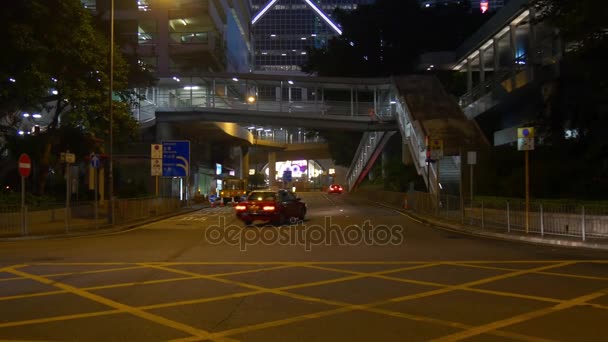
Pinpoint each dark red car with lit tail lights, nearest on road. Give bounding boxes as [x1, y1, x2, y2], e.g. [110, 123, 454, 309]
[234, 189, 307, 225]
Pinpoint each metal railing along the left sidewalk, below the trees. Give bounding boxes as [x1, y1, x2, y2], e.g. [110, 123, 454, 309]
[0, 197, 186, 237]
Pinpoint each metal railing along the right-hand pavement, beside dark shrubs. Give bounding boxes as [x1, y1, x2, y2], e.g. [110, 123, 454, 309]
[408, 192, 608, 241]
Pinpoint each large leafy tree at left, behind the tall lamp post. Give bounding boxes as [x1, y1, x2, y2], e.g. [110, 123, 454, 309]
[0, 0, 137, 193]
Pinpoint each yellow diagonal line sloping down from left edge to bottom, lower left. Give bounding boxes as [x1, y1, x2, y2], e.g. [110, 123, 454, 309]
[8, 269, 217, 338]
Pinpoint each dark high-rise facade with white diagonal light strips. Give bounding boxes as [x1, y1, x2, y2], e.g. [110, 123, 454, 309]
[251, 0, 375, 72]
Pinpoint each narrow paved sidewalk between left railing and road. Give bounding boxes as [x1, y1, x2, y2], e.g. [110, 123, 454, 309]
[0, 204, 209, 242]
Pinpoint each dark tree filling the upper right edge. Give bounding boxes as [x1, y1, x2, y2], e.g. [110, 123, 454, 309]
[531, 0, 608, 195]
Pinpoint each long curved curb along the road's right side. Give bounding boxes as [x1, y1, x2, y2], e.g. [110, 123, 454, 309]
[360, 201, 608, 251]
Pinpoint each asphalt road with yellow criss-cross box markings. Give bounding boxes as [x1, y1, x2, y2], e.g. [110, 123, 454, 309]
[0, 193, 608, 341]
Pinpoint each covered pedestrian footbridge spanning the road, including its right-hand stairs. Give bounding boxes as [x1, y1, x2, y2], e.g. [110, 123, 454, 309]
[134, 73, 484, 192]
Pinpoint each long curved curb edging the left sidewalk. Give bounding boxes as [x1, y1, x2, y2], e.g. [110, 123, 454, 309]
[0, 207, 208, 242]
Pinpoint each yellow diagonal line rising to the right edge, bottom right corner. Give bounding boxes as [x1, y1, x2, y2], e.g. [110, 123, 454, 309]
[434, 292, 606, 342]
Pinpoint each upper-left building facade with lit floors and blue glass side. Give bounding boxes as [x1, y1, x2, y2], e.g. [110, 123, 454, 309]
[81, 0, 253, 75]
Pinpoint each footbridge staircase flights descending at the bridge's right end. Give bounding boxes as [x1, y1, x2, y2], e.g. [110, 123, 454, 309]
[347, 76, 487, 194]
